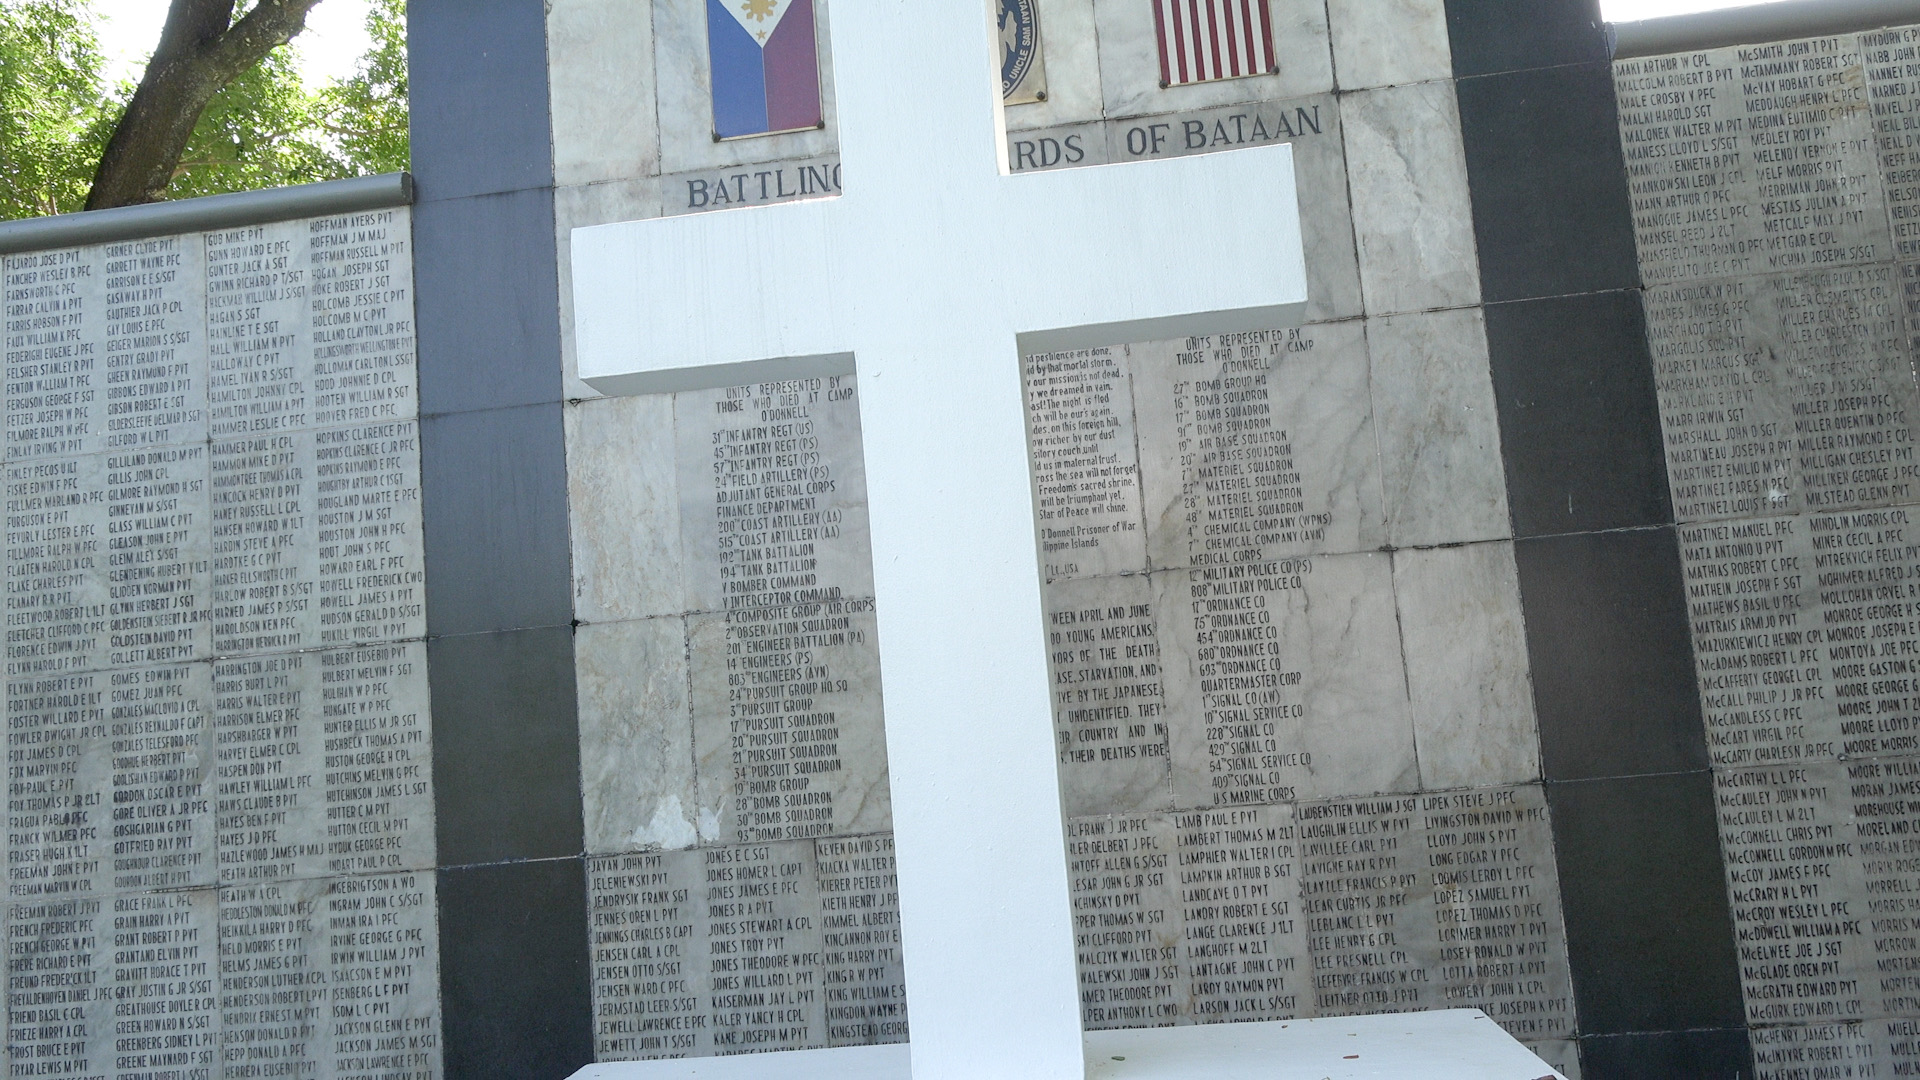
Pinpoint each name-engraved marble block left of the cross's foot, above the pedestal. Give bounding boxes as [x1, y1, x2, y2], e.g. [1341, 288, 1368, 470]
[588, 834, 890, 1061]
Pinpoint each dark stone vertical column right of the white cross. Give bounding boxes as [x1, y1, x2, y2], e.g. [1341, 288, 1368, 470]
[1446, 0, 1751, 1080]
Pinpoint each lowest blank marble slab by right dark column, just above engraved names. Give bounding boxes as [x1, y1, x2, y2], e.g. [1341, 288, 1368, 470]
[1394, 542, 1540, 790]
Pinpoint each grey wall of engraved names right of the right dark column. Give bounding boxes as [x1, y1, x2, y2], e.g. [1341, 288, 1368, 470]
[1615, 27, 1920, 1078]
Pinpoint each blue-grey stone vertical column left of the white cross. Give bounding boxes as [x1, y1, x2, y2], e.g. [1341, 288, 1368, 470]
[407, 0, 593, 1080]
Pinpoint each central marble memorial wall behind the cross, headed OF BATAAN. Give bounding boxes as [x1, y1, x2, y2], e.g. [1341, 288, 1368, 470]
[547, 0, 1578, 1074]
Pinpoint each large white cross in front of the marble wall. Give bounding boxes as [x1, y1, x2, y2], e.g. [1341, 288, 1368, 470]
[572, 0, 1308, 1080]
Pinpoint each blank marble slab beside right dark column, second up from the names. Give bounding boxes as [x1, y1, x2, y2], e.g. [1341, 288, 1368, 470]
[1367, 307, 1513, 548]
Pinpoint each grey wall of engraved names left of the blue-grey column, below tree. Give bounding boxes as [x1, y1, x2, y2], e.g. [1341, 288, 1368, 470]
[4, 208, 442, 1080]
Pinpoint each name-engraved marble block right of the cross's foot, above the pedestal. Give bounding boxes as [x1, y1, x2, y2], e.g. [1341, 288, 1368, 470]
[1068, 786, 1572, 1042]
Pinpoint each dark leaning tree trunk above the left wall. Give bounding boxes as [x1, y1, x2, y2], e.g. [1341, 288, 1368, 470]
[86, 0, 321, 209]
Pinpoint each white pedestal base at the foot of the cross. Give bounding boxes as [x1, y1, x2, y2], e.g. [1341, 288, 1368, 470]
[572, 1009, 1565, 1080]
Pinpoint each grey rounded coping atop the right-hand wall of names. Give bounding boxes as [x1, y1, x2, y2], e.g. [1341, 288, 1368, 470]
[1607, 0, 1920, 60]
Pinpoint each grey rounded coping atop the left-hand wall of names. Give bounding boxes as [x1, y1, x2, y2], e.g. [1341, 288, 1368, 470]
[0, 173, 413, 256]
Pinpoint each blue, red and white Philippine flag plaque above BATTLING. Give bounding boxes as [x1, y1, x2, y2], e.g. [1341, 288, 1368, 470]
[707, 0, 822, 138]
